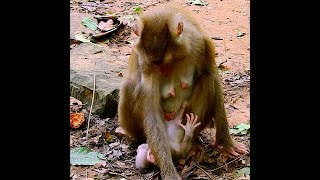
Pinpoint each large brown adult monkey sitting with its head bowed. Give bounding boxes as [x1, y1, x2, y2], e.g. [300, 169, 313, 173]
[118, 5, 246, 179]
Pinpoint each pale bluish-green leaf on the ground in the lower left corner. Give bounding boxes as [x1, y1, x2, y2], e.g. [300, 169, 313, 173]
[70, 147, 105, 165]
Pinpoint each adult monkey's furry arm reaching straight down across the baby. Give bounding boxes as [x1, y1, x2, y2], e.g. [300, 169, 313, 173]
[143, 75, 181, 179]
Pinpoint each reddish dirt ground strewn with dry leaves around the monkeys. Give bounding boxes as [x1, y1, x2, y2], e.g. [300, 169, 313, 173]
[70, 0, 250, 179]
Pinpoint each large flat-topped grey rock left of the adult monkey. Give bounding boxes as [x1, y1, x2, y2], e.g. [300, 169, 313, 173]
[70, 43, 125, 118]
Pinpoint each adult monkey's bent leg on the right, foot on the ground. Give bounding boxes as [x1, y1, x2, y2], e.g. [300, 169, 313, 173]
[190, 73, 246, 156]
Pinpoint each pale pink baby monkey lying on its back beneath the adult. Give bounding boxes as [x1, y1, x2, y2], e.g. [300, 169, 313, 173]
[135, 103, 201, 173]
